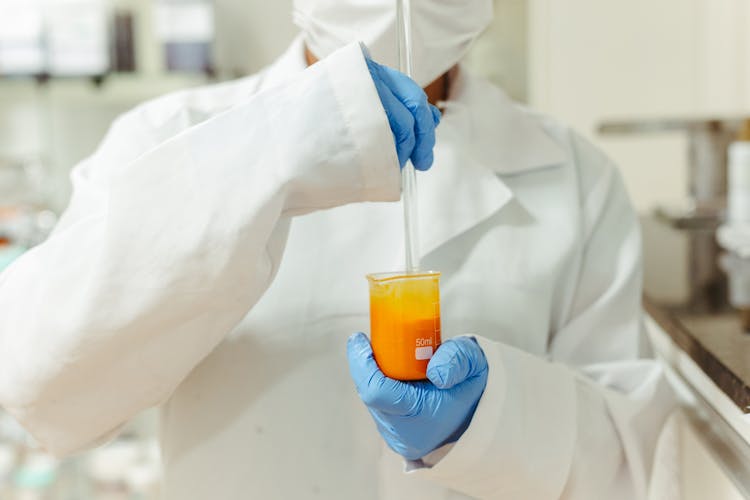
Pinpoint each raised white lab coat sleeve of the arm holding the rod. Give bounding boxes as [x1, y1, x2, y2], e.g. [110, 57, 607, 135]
[0, 44, 400, 455]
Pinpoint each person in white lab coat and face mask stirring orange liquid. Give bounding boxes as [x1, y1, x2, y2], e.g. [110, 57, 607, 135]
[0, 0, 673, 500]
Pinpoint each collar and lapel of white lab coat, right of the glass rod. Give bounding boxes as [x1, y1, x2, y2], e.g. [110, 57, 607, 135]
[418, 68, 565, 257]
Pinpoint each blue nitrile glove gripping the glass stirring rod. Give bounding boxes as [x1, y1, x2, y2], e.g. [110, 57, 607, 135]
[365, 57, 440, 170]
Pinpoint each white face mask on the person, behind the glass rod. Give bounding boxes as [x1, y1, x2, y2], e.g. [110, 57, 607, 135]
[294, 0, 493, 87]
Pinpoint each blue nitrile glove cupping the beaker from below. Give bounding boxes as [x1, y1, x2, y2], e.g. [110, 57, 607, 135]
[347, 333, 488, 460]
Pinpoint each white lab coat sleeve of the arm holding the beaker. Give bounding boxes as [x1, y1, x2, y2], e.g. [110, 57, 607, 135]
[415, 143, 674, 500]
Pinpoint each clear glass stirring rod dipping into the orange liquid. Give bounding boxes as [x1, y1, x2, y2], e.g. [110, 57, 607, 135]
[396, 0, 419, 273]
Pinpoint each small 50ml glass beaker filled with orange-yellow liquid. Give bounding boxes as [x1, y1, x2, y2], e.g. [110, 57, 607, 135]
[367, 271, 440, 380]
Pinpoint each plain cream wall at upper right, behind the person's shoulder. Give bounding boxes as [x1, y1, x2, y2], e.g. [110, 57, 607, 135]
[529, 0, 750, 210]
